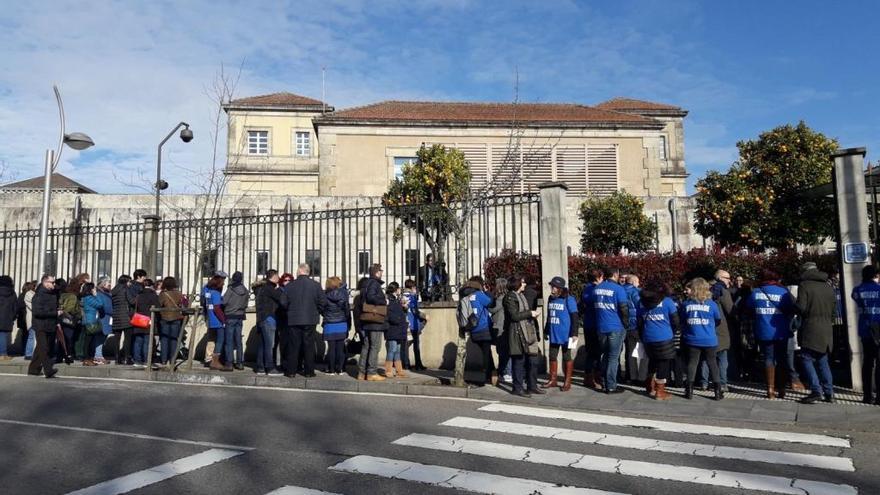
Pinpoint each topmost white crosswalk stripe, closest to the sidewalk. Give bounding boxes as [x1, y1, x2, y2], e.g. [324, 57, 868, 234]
[480, 404, 850, 448]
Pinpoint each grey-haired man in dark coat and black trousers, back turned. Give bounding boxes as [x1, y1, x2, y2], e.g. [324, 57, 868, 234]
[281, 263, 327, 377]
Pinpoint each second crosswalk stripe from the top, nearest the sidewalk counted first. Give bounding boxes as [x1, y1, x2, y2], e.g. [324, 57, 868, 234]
[440, 416, 856, 472]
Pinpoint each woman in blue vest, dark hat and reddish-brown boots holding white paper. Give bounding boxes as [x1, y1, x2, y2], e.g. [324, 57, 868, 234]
[541, 277, 580, 392]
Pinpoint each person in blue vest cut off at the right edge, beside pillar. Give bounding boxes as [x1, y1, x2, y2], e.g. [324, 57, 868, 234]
[852, 265, 880, 405]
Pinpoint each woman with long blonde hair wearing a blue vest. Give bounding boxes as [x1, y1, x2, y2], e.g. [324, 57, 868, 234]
[679, 277, 724, 400]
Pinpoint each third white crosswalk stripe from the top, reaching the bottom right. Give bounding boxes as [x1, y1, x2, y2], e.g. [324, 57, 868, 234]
[392, 433, 858, 495]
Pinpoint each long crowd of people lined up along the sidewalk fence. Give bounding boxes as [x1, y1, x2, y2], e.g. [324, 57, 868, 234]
[0, 256, 880, 403]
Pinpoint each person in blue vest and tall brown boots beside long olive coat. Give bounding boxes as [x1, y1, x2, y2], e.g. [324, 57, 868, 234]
[746, 270, 796, 399]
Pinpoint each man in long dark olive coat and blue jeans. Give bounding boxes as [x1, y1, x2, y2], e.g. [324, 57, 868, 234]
[797, 266, 837, 404]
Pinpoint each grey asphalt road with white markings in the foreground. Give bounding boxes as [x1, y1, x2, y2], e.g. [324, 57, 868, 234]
[0, 376, 880, 495]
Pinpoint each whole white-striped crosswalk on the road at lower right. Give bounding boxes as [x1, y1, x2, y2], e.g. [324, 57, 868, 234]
[318, 403, 859, 495]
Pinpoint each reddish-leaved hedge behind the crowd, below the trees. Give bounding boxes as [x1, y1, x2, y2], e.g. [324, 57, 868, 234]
[483, 249, 837, 294]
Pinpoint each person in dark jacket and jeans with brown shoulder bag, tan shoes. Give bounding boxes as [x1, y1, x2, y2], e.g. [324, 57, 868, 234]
[358, 263, 388, 382]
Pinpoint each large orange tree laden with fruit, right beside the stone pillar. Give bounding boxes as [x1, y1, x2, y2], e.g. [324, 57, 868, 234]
[694, 122, 838, 251]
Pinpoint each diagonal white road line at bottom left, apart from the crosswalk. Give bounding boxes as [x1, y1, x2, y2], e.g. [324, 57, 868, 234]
[68, 449, 244, 495]
